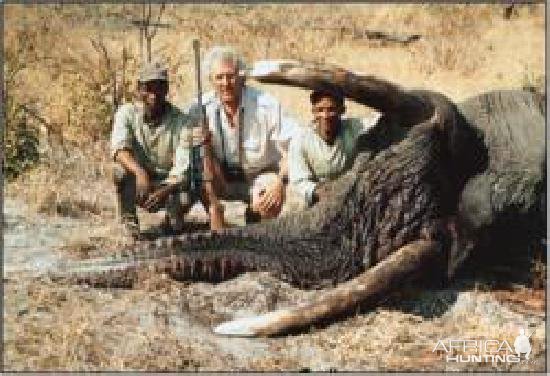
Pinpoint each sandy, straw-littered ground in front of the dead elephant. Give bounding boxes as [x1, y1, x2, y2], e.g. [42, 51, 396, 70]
[4, 195, 545, 371]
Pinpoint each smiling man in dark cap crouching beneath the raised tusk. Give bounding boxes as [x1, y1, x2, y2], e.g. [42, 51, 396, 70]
[288, 86, 384, 209]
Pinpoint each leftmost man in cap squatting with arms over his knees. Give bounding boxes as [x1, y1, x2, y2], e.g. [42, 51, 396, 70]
[111, 62, 198, 237]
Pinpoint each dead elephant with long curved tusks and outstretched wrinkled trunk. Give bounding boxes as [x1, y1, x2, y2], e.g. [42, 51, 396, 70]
[48, 61, 546, 336]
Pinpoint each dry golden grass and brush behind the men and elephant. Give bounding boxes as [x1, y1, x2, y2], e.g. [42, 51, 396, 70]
[5, 4, 544, 216]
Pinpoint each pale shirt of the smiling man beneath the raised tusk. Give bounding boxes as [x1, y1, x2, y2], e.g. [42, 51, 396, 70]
[288, 115, 378, 206]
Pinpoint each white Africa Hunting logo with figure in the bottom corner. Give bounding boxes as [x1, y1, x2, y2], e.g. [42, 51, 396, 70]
[432, 328, 533, 363]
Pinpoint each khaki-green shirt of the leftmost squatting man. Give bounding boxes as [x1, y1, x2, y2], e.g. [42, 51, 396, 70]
[111, 103, 192, 184]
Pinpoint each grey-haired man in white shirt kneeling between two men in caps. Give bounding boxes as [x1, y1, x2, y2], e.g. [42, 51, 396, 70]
[190, 47, 297, 225]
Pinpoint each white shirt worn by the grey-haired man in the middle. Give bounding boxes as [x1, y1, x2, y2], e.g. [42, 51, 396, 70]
[189, 86, 298, 177]
